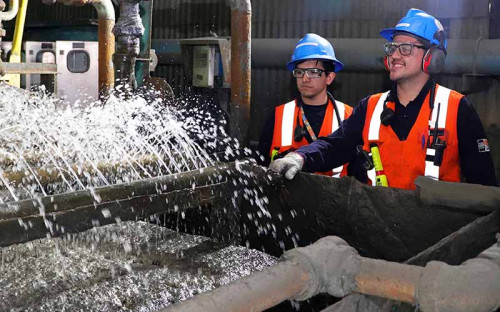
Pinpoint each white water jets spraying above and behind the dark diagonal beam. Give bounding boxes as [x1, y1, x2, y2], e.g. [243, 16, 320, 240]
[0, 87, 236, 202]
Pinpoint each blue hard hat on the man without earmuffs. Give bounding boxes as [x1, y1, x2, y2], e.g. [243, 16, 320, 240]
[286, 34, 344, 72]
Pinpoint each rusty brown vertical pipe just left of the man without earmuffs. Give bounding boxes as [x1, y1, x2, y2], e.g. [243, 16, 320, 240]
[231, 0, 252, 145]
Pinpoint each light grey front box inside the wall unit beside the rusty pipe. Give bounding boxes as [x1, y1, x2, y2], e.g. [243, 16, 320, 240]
[193, 46, 215, 88]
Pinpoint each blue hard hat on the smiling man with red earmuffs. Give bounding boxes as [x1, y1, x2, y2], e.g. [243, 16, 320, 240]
[380, 9, 447, 50]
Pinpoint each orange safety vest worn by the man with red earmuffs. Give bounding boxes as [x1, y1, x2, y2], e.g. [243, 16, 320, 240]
[363, 85, 463, 190]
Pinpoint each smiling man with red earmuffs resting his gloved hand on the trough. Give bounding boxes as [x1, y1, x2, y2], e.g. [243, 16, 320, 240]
[270, 9, 497, 189]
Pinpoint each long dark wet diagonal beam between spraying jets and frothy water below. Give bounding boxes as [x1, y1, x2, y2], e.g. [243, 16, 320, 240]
[0, 160, 269, 246]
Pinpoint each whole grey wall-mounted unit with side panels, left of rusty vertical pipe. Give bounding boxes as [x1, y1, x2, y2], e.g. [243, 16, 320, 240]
[179, 37, 231, 88]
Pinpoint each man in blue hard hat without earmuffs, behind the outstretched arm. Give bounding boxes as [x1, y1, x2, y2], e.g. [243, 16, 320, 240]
[259, 34, 364, 176]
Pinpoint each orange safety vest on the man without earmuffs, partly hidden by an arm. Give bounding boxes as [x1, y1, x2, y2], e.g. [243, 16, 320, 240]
[269, 100, 352, 177]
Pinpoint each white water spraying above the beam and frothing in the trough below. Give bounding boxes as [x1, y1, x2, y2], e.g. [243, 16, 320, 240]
[0, 81, 292, 311]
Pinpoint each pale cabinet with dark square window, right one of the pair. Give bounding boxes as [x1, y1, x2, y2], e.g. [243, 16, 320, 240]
[56, 41, 99, 104]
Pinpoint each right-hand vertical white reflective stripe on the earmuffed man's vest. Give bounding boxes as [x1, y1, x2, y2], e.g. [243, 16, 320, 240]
[425, 86, 451, 180]
